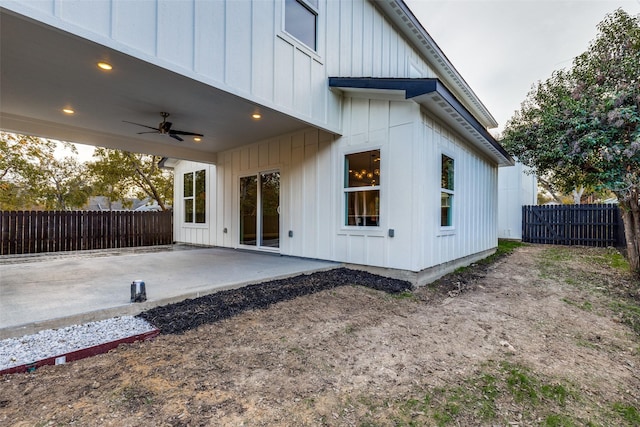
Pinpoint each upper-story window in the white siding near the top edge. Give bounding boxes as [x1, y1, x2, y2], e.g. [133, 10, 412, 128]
[284, 0, 318, 50]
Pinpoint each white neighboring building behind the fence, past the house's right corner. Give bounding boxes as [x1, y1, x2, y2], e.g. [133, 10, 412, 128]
[498, 162, 538, 240]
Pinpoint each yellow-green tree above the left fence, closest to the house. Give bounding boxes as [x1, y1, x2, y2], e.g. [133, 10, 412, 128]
[88, 148, 173, 210]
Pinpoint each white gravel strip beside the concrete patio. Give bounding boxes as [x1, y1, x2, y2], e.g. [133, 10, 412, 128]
[0, 316, 155, 371]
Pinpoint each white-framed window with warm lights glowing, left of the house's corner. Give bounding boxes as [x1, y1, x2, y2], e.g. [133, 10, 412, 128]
[344, 150, 381, 227]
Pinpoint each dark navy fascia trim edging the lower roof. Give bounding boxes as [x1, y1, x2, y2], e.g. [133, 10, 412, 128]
[329, 77, 513, 162]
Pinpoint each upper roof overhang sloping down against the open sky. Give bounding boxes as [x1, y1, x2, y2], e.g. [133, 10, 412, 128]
[370, 0, 498, 128]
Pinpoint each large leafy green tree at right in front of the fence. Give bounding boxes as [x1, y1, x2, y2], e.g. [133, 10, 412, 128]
[501, 9, 640, 272]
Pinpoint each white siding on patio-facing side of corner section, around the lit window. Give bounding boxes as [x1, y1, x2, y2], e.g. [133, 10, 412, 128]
[334, 97, 419, 270]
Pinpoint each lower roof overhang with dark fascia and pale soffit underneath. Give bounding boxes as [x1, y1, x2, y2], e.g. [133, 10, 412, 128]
[329, 77, 515, 166]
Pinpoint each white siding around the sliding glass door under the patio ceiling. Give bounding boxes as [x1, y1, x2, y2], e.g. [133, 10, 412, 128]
[211, 128, 336, 260]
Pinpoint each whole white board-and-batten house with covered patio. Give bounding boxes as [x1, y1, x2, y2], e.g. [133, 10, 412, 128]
[0, 0, 513, 284]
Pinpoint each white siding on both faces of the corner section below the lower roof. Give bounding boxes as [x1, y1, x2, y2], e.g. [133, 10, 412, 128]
[335, 98, 497, 272]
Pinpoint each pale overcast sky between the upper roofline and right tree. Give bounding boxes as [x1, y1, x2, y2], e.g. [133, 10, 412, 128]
[405, 0, 640, 131]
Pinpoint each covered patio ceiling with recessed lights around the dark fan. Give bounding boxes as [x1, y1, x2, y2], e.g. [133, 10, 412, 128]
[0, 8, 308, 162]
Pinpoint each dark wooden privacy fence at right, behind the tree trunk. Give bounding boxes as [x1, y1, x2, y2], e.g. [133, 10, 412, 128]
[522, 205, 625, 247]
